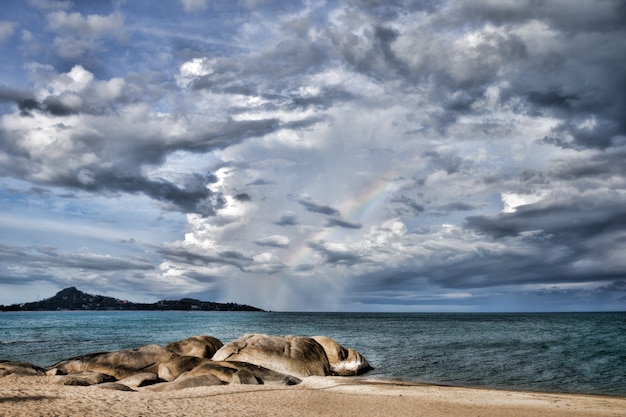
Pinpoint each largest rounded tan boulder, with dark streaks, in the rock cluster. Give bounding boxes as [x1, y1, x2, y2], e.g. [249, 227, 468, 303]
[212, 334, 331, 377]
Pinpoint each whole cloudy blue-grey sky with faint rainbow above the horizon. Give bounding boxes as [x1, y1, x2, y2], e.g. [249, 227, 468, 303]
[0, 0, 626, 312]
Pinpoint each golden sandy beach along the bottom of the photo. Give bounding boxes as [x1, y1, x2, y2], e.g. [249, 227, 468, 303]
[0, 375, 626, 417]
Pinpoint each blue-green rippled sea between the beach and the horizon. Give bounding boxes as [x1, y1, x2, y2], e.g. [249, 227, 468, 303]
[0, 311, 626, 397]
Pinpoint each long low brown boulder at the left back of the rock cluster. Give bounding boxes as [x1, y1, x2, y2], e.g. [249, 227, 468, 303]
[50, 345, 176, 379]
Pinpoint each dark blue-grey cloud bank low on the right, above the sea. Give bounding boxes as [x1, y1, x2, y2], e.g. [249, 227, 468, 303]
[442, 198, 626, 288]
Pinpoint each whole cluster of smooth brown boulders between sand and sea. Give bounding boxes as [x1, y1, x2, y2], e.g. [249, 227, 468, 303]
[0, 334, 371, 391]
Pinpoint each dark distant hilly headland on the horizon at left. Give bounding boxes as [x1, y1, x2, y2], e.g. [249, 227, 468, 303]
[0, 287, 263, 311]
